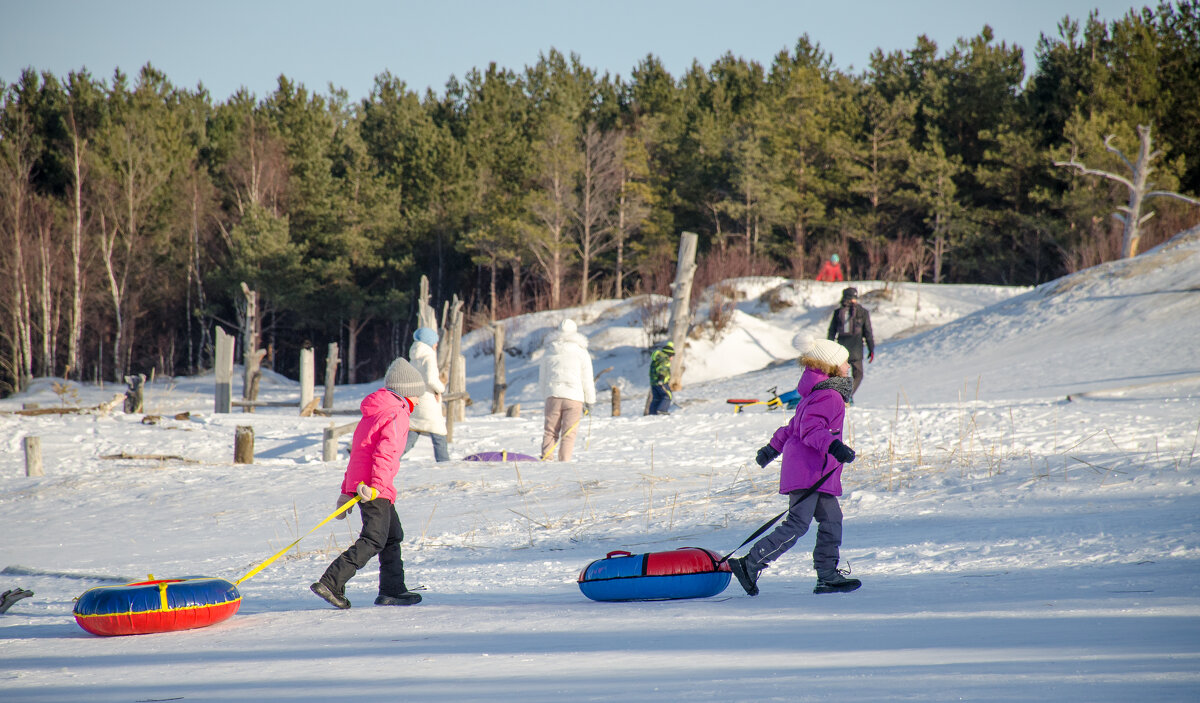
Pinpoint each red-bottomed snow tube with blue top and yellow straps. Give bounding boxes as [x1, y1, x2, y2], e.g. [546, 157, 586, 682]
[74, 576, 241, 636]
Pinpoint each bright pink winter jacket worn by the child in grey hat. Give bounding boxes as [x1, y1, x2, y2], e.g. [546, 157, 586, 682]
[342, 389, 415, 503]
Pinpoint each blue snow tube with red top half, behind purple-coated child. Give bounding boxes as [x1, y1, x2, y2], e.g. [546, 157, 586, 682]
[580, 547, 731, 601]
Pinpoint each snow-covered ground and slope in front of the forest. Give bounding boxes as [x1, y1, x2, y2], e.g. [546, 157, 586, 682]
[7, 226, 1200, 702]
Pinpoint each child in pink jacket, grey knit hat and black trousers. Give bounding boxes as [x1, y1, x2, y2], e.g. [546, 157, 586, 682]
[310, 359, 425, 609]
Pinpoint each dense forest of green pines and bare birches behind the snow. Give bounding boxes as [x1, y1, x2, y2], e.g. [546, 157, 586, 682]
[0, 0, 1200, 395]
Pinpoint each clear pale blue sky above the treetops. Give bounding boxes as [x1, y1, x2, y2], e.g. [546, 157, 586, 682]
[0, 0, 1141, 100]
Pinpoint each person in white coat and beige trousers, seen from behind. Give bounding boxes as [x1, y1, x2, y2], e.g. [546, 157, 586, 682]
[538, 318, 596, 462]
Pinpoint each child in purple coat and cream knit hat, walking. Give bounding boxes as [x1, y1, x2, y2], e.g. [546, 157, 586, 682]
[730, 340, 863, 595]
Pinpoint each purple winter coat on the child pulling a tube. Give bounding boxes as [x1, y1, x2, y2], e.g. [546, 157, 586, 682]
[770, 368, 846, 495]
